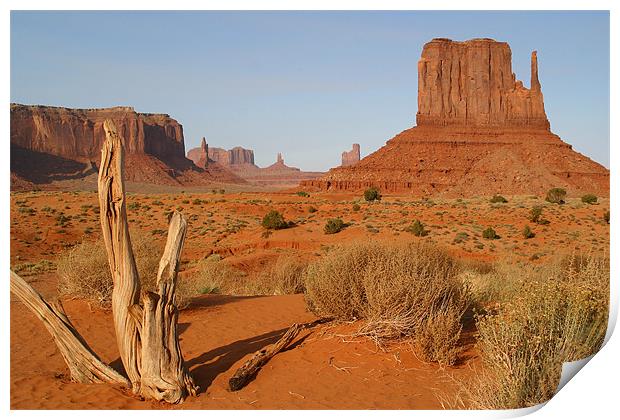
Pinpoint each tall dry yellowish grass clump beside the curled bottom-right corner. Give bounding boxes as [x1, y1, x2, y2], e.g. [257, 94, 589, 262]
[453, 255, 609, 409]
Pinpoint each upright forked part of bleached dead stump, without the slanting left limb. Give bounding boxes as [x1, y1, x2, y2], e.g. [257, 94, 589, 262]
[99, 120, 197, 403]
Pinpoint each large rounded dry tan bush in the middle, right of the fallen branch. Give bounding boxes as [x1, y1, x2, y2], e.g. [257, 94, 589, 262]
[305, 243, 468, 364]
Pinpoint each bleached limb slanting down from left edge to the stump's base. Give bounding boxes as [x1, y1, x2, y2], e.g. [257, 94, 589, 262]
[11, 271, 129, 387]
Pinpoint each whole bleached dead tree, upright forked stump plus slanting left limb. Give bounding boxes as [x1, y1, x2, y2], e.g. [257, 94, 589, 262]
[11, 120, 198, 404]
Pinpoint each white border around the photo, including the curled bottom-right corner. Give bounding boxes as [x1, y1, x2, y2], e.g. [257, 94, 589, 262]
[0, 0, 620, 420]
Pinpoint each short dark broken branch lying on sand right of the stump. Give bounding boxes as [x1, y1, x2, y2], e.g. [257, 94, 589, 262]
[228, 319, 329, 391]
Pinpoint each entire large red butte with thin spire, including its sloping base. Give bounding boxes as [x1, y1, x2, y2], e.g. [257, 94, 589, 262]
[302, 38, 609, 196]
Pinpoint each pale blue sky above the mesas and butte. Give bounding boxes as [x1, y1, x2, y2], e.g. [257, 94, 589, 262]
[11, 11, 609, 170]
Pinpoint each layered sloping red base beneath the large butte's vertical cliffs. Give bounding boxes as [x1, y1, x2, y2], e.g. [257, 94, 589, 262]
[302, 127, 609, 196]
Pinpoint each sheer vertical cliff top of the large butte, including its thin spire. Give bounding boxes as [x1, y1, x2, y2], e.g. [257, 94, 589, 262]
[416, 38, 549, 130]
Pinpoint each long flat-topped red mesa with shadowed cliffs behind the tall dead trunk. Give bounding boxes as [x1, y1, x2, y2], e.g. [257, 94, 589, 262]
[11, 104, 243, 185]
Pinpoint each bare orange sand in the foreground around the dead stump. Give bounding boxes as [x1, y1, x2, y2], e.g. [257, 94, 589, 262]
[10, 282, 475, 409]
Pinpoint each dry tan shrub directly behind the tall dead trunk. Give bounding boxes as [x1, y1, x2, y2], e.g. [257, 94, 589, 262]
[57, 231, 163, 307]
